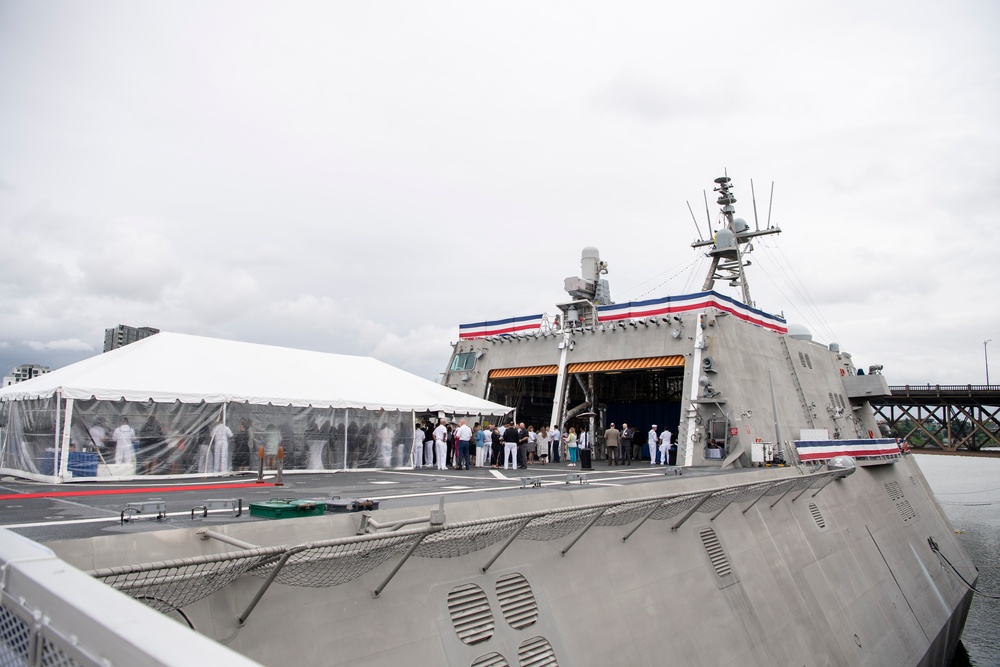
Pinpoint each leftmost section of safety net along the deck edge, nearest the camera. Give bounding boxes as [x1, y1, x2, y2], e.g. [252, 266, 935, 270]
[87, 547, 285, 612]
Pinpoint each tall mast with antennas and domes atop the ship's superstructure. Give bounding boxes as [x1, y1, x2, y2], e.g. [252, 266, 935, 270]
[691, 176, 781, 306]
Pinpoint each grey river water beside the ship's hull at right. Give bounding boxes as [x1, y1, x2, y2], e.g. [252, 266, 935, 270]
[914, 454, 1000, 667]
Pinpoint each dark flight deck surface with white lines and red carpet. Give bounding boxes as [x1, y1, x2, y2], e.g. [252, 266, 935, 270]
[0, 461, 756, 542]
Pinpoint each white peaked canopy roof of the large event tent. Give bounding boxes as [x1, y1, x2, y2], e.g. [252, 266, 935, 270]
[0, 332, 509, 415]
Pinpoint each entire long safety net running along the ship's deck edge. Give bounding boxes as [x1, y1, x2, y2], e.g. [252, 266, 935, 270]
[90, 471, 842, 608]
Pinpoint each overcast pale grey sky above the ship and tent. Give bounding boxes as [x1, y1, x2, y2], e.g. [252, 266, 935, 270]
[0, 0, 1000, 384]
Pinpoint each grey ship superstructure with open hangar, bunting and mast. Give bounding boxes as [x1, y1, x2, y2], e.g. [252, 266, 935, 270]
[443, 177, 889, 467]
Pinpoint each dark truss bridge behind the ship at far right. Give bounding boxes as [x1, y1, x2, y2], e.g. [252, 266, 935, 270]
[871, 384, 1000, 452]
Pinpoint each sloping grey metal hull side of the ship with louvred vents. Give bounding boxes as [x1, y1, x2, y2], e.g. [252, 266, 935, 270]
[43, 456, 975, 666]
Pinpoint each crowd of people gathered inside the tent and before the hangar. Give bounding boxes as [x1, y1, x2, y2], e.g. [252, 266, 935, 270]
[73, 416, 672, 474]
